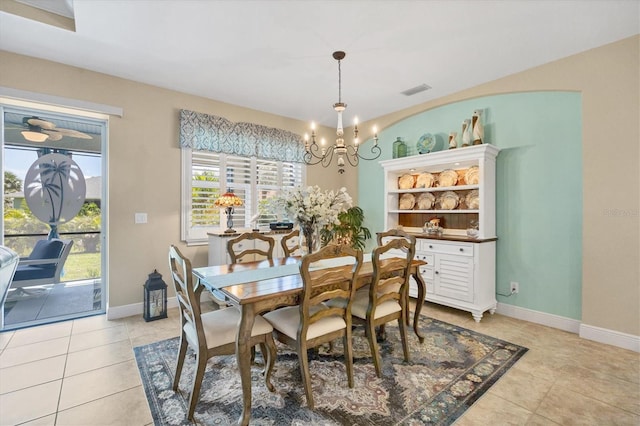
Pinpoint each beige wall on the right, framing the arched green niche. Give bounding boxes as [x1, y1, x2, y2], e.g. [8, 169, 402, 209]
[362, 36, 640, 336]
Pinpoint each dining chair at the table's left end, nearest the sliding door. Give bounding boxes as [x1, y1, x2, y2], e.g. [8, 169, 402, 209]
[169, 245, 276, 420]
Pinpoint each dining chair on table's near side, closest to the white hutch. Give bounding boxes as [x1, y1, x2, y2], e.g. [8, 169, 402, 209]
[351, 236, 415, 377]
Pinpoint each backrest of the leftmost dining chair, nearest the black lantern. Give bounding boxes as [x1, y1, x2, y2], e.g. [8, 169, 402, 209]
[169, 245, 207, 354]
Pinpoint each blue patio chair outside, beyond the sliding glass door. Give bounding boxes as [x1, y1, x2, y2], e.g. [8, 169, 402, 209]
[11, 238, 73, 289]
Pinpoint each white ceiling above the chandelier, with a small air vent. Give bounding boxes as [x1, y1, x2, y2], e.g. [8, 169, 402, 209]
[0, 0, 640, 126]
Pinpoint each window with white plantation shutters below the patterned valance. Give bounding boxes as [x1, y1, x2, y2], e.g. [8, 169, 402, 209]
[182, 148, 304, 244]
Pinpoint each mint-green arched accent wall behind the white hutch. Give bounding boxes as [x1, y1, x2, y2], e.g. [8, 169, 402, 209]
[358, 92, 584, 320]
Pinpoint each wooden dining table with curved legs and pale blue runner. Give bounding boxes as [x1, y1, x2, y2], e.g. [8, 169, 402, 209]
[193, 253, 426, 426]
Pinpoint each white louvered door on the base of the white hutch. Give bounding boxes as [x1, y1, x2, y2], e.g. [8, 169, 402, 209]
[434, 254, 473, 302]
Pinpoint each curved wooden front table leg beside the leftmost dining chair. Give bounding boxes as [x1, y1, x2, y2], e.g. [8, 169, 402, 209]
[236, 304, 255, 426]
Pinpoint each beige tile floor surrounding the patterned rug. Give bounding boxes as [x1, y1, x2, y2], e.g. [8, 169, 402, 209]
[0, 304, 640, 426]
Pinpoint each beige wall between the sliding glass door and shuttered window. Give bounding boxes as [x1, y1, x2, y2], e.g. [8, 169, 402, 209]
[0, 51, 344, 307]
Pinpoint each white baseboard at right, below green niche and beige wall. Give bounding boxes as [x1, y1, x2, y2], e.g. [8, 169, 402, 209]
[496, 303, 640, 352]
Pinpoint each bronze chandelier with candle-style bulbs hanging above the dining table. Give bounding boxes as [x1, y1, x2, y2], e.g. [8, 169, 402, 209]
[303, 51, 382, 173]
